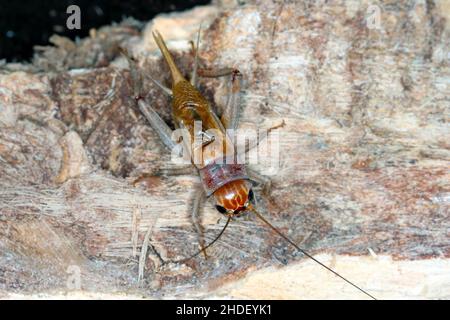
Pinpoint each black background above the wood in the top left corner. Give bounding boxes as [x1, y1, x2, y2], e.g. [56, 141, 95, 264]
[0, 0, 211, 61]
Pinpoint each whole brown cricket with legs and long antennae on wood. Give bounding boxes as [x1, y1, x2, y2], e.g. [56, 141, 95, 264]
[122, 30, 376, 300]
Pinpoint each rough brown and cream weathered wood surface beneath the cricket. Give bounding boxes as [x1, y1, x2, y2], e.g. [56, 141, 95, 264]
[0, 1, 450, 298]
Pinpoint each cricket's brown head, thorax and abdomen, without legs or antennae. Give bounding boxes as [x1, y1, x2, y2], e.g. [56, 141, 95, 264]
[154, 33, 251, 215]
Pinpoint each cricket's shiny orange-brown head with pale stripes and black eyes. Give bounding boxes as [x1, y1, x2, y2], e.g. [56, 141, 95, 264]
[214, 180, 254, 217]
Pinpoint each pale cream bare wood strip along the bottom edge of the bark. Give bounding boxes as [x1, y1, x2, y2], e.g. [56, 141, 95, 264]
[0, 252, 450, 300]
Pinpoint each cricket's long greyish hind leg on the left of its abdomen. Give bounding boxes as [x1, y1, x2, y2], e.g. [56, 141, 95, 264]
[122, 50, 181, 152]
